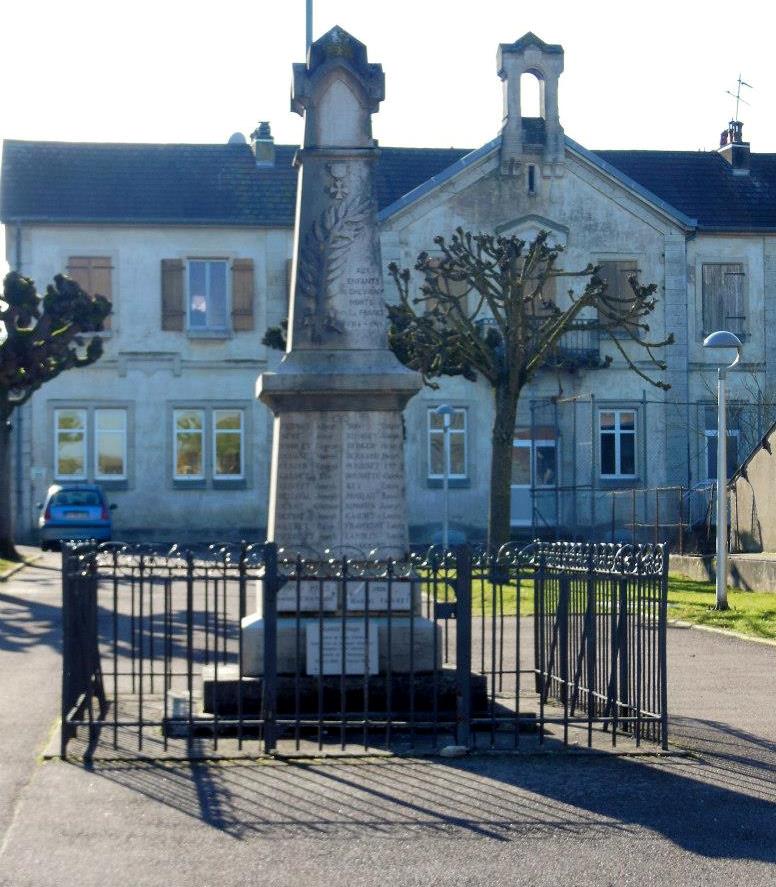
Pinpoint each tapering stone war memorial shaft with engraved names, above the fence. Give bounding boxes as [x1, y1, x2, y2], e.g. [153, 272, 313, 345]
[257, 27, 421, 557]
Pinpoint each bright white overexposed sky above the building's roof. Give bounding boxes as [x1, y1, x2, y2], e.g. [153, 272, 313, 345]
[0, 0, 776, 268]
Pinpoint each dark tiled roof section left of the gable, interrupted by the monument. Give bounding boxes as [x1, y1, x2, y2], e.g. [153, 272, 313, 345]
[0, 141, 466, 227]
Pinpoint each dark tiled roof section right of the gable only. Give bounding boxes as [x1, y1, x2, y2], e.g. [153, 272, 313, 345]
[595, 151, 776, 231]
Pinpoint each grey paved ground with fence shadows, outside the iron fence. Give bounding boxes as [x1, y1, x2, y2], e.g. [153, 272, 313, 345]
[0, 559, 776, 887]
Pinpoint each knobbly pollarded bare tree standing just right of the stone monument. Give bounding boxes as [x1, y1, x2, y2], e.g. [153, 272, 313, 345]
[388, 228, 673, 546]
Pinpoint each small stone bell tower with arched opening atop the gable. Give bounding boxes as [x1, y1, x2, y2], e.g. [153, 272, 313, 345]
[496, 31, 564, 176]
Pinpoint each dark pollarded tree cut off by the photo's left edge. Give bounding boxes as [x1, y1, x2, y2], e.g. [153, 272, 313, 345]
[0, 271, 111, 560]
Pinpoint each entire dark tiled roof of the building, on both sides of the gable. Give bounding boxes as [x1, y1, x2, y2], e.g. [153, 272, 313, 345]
[6, 135, 776, 231]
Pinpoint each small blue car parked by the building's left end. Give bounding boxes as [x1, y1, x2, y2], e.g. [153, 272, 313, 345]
[38, 484, 116, 551]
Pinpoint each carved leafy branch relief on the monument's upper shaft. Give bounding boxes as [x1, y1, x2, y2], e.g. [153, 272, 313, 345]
[297, 194, 373, 343]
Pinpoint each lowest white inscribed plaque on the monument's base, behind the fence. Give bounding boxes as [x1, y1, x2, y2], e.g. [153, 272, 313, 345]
[305, 619, 378, 675]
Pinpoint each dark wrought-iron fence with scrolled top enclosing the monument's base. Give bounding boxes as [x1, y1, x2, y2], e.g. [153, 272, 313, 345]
[61, 543, 667, 758]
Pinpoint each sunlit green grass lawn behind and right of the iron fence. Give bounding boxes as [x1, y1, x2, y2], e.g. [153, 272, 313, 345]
[460, 576, 776, 639]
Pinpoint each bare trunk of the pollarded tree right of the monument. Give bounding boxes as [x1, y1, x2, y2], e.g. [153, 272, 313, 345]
[488, 385, 518, 548]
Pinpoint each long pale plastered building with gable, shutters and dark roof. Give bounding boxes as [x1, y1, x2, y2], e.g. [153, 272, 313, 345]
[0, 34, 776, 539]
